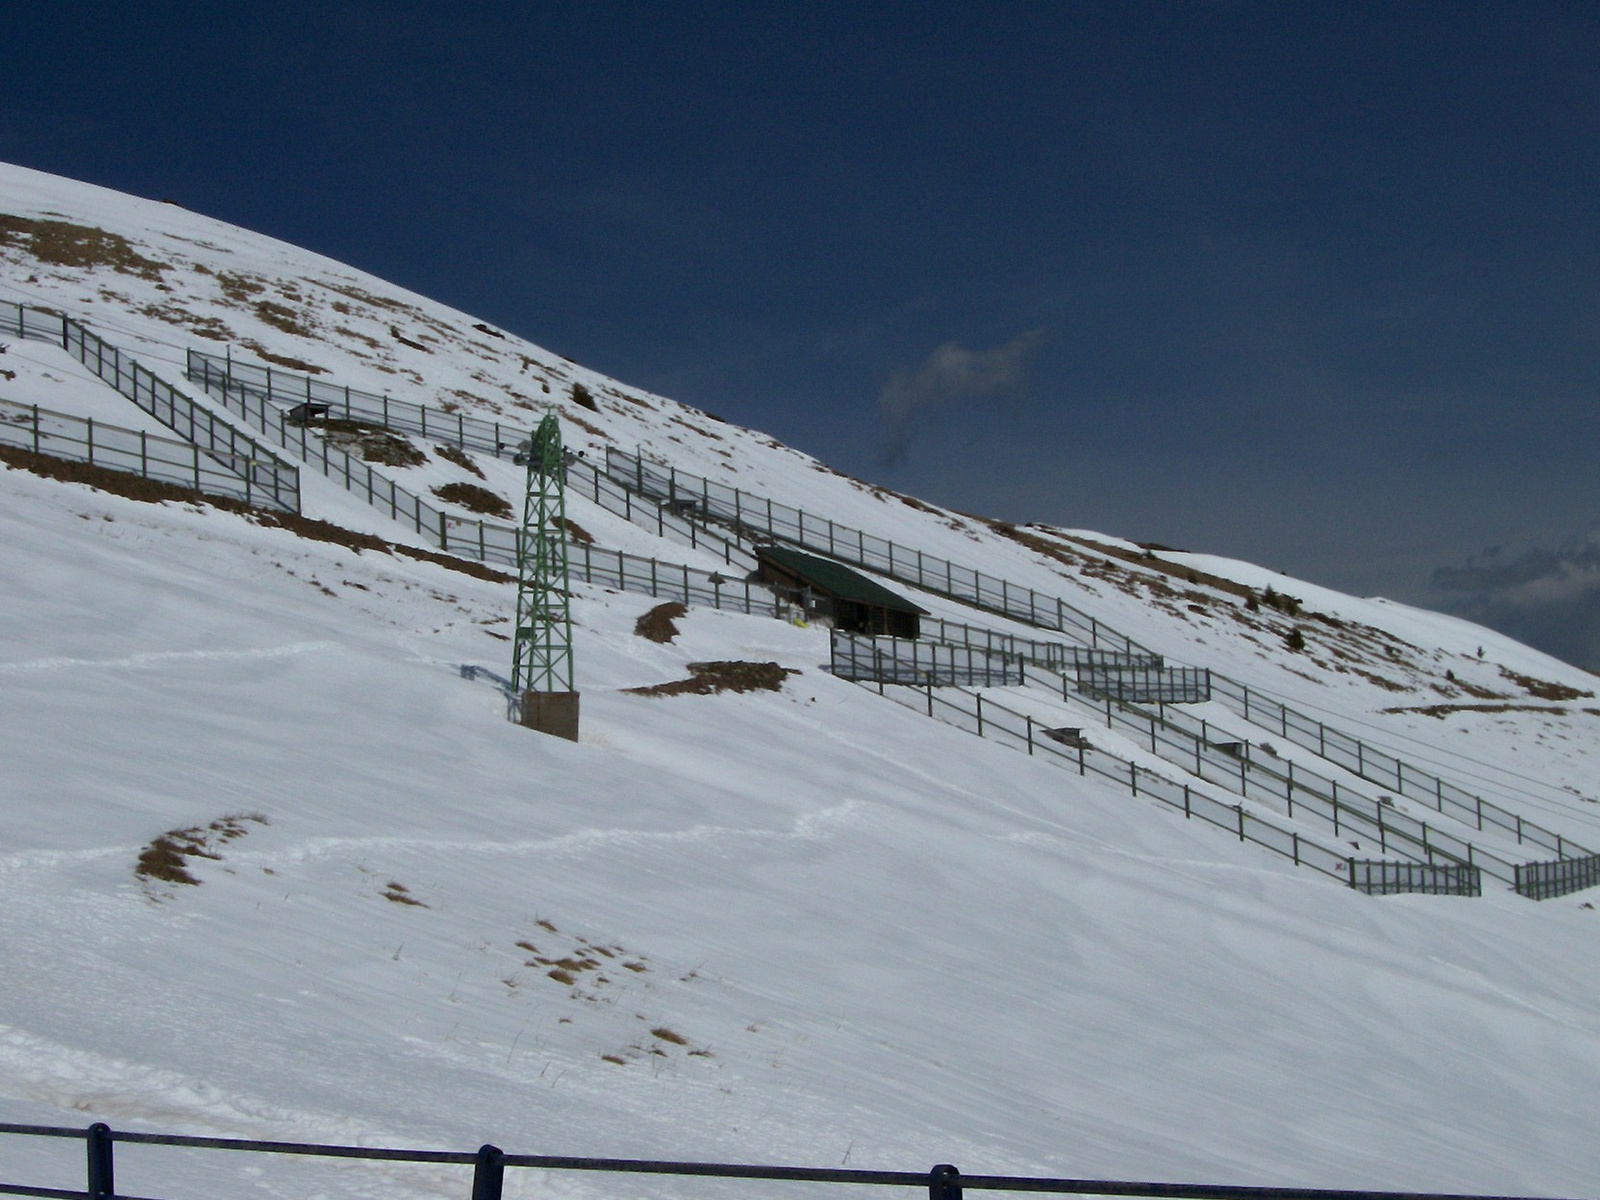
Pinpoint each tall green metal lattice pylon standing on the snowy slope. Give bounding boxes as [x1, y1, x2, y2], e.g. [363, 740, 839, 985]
[510, 414, 576, 704]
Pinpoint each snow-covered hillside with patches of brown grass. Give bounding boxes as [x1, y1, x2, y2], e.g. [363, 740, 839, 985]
[0, 168, 1600, 1195]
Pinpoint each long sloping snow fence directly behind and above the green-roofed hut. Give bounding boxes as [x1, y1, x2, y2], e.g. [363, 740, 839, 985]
[606, 446, 1149, 653]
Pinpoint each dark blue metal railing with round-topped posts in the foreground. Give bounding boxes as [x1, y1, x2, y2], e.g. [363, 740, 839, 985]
[0, 1123, 1568, 1200]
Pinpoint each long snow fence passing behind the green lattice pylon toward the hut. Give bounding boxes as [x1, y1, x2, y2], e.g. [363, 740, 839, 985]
[190, 355, 790, 616]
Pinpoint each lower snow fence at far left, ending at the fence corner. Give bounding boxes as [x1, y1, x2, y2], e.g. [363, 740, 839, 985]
[0, 400, 284, 504]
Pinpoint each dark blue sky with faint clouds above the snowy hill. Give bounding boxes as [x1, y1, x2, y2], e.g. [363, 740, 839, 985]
[9, 0, 1600, 667]
